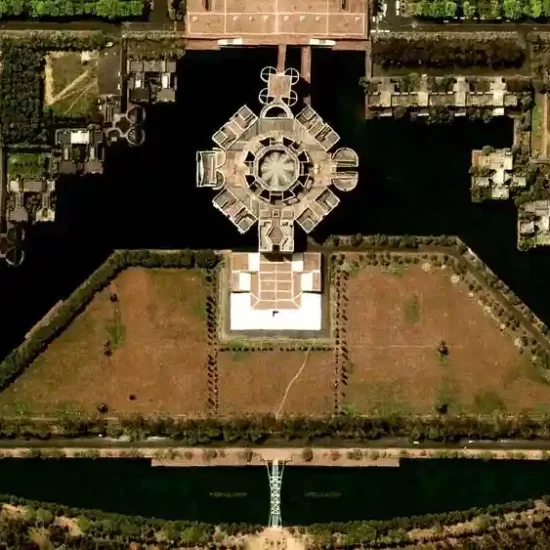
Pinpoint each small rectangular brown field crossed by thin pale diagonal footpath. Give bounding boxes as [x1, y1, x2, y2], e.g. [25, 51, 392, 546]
[218, 351, 334, 415]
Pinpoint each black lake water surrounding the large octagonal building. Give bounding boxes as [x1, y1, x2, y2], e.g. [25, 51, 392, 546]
[0, 48, 550, 355]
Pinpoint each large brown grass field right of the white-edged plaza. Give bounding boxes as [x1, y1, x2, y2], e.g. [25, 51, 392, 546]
[344, 265, 550, 414]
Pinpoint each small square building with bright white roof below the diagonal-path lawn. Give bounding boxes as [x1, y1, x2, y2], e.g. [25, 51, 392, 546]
[54, 126, 105, 174]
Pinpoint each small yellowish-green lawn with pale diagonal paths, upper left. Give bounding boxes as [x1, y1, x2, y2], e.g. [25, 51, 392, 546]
[44, 52, 99, 117]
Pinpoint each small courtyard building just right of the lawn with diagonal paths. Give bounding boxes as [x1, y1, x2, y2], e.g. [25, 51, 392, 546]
[126, 59, 178, 103]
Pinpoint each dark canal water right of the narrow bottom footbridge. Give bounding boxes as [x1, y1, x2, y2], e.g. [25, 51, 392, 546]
[282, 460, 550, 525]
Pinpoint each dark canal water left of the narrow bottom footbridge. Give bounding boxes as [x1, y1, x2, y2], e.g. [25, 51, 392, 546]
[0, 459, 269, 524]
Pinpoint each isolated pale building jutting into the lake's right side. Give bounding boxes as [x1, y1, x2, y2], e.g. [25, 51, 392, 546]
[470, 148, 527, 202]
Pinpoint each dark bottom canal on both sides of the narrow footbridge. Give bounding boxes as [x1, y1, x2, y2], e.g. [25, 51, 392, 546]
[0, 459, 550, 525]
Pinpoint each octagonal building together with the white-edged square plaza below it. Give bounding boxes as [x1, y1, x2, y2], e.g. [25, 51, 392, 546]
[197, 67, 359, 331]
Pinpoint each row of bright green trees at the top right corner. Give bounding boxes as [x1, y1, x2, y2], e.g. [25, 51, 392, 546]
[408, 0, 550, 21]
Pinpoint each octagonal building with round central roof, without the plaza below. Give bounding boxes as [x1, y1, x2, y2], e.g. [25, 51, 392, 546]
[197, 67, 359, 253]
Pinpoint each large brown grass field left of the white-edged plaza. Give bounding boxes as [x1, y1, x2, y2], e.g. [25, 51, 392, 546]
[0, 268, 207, 414]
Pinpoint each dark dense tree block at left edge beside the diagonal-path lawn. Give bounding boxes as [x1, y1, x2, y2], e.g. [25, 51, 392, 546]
[0, 42, 46, 143]
